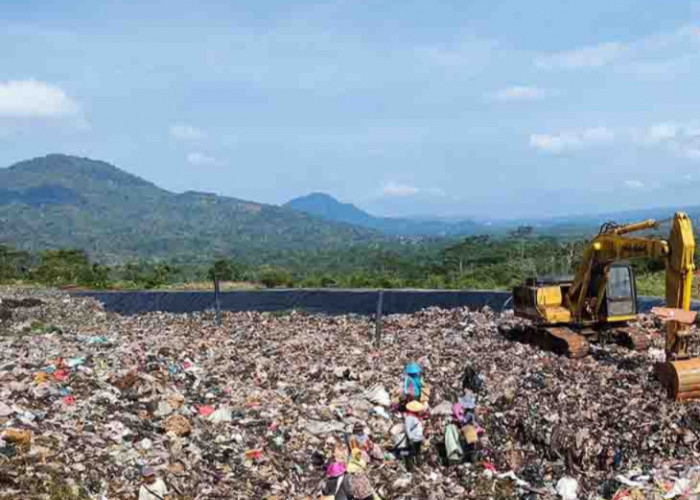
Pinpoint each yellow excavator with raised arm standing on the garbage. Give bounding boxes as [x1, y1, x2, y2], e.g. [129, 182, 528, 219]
[513, 212, 700, 400]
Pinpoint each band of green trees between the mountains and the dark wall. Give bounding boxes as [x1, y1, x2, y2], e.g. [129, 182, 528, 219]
[0, 227, 680, 289]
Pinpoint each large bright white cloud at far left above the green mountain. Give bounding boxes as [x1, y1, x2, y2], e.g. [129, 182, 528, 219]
[0, 80, 80, 118]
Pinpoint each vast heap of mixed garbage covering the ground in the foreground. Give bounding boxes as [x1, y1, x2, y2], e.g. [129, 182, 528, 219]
[0, 288, 700, 500]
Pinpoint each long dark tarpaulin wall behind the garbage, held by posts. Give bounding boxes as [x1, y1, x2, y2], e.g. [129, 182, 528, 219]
[72, 289, 700, 315]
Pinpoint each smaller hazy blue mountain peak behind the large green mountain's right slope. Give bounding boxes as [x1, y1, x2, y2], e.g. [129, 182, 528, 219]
[283, 193, 489, 236]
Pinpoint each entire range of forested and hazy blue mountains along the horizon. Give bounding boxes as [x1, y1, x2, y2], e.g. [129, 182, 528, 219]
[0, 155, 700, 262]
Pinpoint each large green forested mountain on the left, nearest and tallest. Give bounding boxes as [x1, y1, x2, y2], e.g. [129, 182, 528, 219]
[0, 154, 382, 261]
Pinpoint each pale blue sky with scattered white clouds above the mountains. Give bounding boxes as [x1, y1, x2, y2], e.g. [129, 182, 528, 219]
[0, 0, 700, 219]
